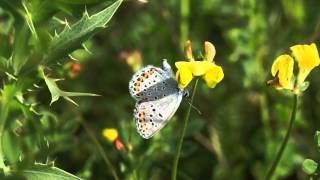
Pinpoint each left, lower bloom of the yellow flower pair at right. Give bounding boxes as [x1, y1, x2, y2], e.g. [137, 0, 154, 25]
[271, 54, 294, 89]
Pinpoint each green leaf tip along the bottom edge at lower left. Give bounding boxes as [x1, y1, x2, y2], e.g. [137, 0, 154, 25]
[23, 163, 81, 180]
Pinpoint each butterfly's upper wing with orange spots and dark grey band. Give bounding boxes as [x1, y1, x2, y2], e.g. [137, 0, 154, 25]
[129, 60, 177, 101]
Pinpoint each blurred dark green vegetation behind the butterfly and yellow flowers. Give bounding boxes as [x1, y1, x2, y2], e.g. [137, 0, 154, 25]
[0, 0, 320, 180]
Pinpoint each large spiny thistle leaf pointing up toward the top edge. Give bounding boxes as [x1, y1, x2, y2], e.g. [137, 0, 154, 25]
[43, 0, 122, 63]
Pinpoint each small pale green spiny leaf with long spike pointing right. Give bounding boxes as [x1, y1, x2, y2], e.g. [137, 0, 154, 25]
[40, 67, 99, 106]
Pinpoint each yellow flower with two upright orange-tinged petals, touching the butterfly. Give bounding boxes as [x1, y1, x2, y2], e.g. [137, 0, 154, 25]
[175, 41, 224, 89]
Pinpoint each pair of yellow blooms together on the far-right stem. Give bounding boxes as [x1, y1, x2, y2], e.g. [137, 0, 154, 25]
[268, 43, 320, 90]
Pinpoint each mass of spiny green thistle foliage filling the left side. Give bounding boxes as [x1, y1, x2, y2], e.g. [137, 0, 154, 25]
[0, 0, 122, 179]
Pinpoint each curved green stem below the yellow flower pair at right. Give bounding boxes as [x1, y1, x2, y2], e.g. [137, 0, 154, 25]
[265, 94, 298, 180]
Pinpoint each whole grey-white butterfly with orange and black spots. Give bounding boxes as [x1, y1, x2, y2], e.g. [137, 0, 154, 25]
[129, 60, 188, 139]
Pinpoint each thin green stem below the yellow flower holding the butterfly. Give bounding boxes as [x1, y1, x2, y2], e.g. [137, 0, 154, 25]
[171, 78, 199, 180]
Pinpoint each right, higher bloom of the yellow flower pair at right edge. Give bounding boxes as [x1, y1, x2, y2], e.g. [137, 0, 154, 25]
[290, 43, 320, 83]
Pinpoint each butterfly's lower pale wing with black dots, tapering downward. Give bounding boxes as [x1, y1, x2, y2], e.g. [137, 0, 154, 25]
[134, 90, 183, 139]
